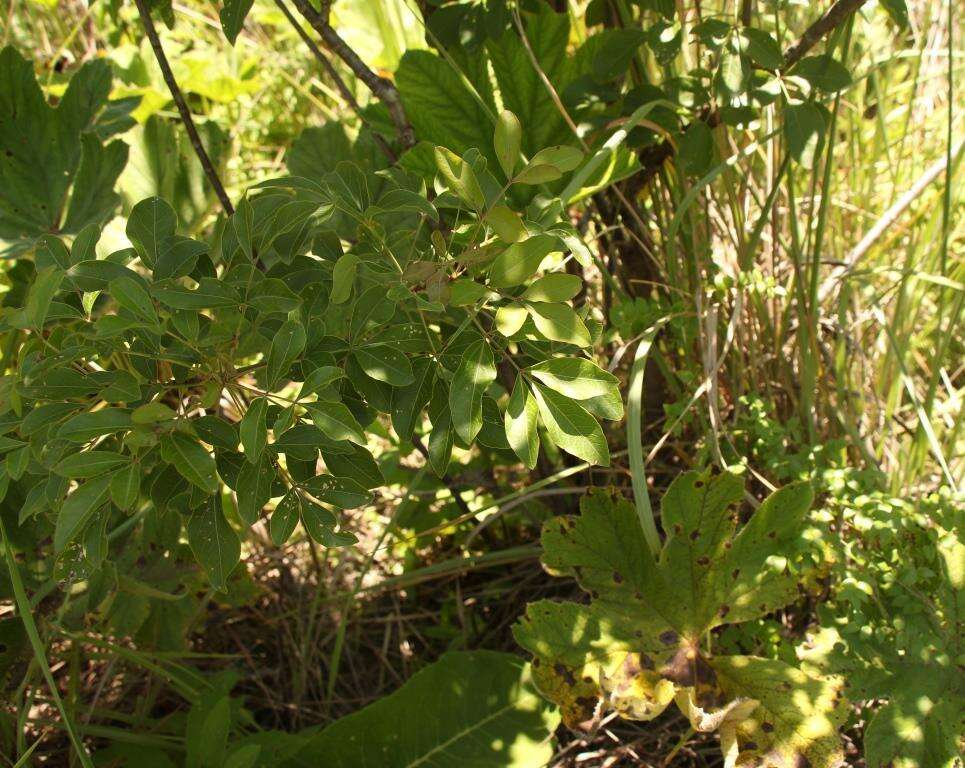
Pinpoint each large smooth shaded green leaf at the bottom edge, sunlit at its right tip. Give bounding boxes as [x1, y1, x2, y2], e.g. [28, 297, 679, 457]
[298, 651, 559, 768]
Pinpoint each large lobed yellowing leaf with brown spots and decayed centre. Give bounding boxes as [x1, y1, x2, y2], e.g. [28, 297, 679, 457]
[514, 472, 846, 768]
